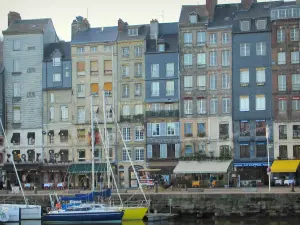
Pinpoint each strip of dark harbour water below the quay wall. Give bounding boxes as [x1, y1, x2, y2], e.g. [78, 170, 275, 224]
[0, 217, 300, 225]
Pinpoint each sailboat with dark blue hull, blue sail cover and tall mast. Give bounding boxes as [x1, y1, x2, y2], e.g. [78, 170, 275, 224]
[43, 95, 124, 223]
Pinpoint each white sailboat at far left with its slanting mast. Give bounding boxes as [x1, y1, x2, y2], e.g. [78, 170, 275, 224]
[0, 119, 42, 222]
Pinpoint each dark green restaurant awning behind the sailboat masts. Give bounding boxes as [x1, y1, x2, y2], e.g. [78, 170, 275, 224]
[68, 163, 107, 174]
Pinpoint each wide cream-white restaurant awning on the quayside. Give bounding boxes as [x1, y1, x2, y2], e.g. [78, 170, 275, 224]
[173, 160, 232, 174]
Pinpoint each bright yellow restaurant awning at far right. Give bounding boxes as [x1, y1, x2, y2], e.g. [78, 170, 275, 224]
[271, 160, 300, 173]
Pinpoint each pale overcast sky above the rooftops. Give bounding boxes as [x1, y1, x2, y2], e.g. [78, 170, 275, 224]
[0, 0, 292, 41]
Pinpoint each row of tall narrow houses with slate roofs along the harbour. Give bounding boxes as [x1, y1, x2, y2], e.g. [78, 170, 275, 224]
[0, 0, 300, 187]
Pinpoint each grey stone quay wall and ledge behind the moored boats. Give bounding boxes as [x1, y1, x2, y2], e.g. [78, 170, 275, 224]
[0, 187, 300, 217]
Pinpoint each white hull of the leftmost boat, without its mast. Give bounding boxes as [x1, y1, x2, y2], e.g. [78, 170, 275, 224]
[0, 204, 42, 222]
